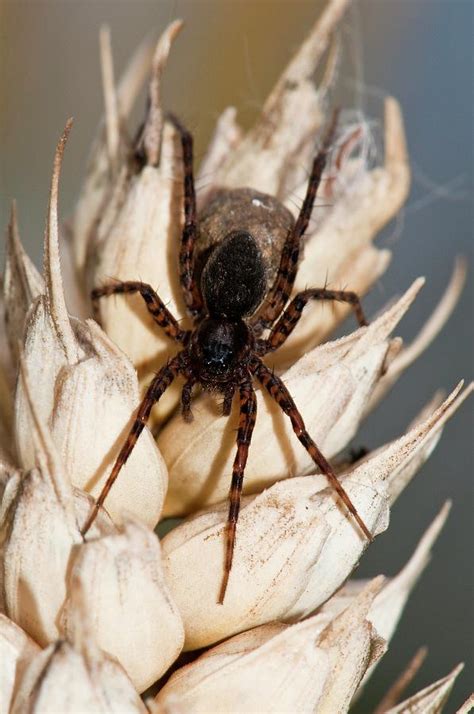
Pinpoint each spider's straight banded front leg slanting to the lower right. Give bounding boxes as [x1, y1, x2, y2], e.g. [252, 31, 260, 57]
[251, 358, 373, 541]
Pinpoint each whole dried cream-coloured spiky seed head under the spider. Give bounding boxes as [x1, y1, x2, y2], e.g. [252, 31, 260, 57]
[0, 0, 472, 714]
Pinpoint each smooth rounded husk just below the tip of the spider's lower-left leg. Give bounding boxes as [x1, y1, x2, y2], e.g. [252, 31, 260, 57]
[61, 523, 184, 692]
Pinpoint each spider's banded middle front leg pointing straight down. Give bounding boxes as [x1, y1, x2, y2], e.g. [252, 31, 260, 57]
[218, 382, 257, 605]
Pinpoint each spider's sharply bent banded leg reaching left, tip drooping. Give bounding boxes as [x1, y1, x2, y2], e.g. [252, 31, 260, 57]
[91, 280, 188, 342]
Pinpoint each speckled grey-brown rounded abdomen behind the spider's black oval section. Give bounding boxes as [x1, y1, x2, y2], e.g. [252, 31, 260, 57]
[196, 188, 294, 287]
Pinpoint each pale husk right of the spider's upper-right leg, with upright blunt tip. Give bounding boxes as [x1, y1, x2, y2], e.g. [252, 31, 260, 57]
[276, 98, 410, 365]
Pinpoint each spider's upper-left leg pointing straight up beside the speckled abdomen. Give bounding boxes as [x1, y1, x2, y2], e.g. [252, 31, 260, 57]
[168, 114, 203, 317]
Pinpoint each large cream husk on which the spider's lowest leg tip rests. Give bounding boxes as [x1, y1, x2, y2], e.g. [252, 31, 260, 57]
[162, 386, 472, 649]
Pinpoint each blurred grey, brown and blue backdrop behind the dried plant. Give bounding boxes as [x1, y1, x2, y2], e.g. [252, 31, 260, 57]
[0, 0, 474, 712]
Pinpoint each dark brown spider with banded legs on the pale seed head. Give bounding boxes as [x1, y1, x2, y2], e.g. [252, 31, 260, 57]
[82, 112, 372, 604]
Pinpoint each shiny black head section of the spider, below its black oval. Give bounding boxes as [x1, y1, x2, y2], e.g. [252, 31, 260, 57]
[192, 317, 250, 383]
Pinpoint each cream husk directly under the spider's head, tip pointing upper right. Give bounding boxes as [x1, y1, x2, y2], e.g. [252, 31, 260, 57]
[158, 280, 423, 516]
